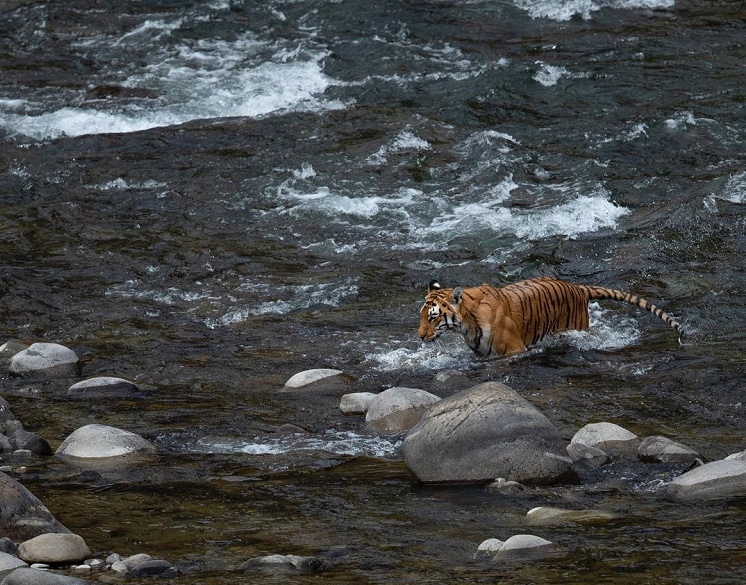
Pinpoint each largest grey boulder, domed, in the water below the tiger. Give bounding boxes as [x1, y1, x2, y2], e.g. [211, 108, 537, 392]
[402, 382, 577, 485]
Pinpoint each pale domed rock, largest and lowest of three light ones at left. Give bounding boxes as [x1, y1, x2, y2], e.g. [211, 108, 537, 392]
[56, 424, 156, 458]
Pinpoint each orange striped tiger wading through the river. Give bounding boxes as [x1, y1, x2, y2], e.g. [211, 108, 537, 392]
[417, 276, 681, 358]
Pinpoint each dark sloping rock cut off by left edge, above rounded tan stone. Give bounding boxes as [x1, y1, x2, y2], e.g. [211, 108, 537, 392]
[0, 473, 70, 541]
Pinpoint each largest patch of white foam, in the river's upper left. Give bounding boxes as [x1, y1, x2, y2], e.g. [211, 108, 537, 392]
[0, 15, 346, 140]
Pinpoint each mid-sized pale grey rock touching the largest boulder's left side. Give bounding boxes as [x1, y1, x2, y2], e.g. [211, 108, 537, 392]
[365, 387, 440, 435]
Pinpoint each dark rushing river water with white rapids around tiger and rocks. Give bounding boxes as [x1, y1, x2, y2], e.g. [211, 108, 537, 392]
[0, 0, 746, 584]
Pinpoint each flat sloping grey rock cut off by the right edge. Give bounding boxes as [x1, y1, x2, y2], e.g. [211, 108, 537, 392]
[666, 459, 746, 500]
